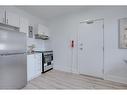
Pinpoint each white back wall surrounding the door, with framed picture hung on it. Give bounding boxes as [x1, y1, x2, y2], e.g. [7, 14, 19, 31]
[49, 7, 127, 83]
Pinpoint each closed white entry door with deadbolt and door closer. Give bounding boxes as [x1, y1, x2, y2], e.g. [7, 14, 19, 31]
[78, 20, 103, 77]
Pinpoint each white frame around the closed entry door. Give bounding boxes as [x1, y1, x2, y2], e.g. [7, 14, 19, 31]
[77, 18, 105, 79]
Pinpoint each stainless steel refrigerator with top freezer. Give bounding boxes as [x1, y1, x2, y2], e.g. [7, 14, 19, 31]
[0, 24, 27, 89]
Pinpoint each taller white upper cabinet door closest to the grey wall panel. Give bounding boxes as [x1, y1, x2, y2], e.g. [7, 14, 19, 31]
[20, 17, 29, 36]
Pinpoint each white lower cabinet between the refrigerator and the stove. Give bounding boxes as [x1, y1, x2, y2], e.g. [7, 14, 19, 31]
[27, 53, 42, 81]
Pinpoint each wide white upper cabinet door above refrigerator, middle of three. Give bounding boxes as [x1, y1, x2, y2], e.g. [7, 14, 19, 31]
[6, 11, 20, 27]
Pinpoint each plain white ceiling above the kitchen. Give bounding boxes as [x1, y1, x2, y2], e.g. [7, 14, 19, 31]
[17, 6, 87, 20]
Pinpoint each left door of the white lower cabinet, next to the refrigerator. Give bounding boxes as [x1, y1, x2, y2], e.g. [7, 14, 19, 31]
[27, 54, 35, 81]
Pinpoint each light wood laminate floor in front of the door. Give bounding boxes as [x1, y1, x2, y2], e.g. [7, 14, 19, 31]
[24, 70, 127, 89]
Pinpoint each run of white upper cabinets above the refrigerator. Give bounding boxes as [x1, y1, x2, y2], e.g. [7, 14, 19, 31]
[0, 9, 29, 36]
